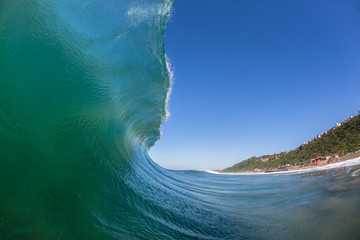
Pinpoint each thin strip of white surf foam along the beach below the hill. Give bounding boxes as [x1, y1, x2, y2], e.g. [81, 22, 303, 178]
[205, 157, 360, 175]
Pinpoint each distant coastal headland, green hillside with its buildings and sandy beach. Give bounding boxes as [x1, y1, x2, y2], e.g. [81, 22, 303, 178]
[221, 114, 360, 173]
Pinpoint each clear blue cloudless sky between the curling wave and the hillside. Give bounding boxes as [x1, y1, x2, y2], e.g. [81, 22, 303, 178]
[150, 0, 360, 169]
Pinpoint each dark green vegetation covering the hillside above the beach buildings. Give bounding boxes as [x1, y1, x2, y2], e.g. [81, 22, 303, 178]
[222, 114, 360, 172]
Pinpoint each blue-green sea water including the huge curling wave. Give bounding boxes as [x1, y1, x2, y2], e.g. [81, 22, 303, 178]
[0, 0, 360, 240]
